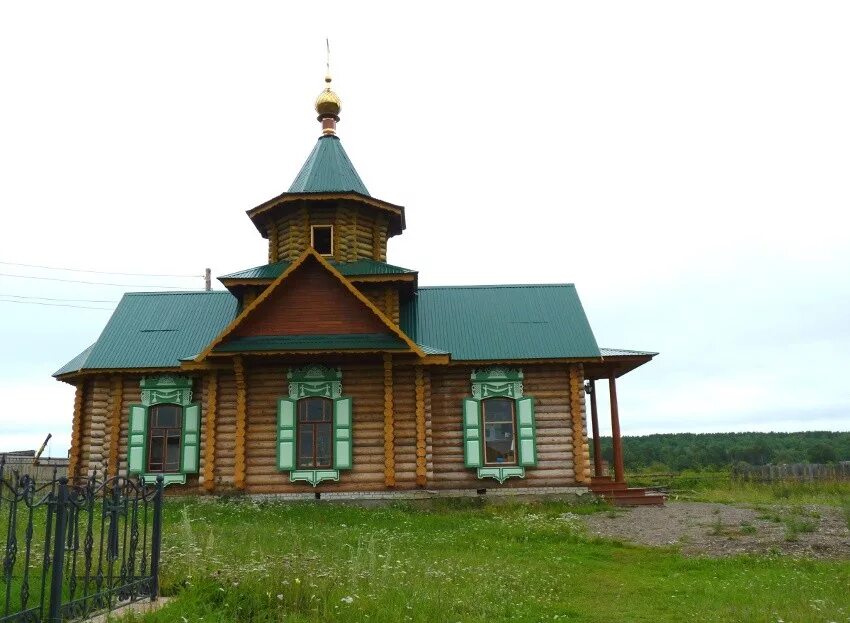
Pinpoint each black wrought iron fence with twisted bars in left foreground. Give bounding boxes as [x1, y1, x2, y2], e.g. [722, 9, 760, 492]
[0, 459, 163, 623]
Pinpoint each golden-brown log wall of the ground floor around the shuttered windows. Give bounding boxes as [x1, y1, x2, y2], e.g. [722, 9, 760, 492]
[70, 356, 589, 493]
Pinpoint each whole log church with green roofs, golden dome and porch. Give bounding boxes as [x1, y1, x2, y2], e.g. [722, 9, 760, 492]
[54, 70, 655, 503]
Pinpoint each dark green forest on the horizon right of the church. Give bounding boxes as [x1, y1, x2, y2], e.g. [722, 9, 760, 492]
[601, 432, 850, 471]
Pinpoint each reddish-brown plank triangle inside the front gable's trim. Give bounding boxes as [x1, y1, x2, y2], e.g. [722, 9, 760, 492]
[231, 258, 391, 338]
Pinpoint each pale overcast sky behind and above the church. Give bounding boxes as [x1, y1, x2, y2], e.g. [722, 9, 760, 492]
[0, 0, 850, 455]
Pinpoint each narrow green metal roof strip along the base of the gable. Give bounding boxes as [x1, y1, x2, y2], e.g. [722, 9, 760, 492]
[214, 333, 407, 353]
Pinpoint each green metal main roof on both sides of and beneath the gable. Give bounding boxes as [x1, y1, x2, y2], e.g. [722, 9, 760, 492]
[54, 284, 604, 376]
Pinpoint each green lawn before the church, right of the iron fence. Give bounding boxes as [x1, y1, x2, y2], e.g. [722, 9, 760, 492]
[109, 501, 850, 623]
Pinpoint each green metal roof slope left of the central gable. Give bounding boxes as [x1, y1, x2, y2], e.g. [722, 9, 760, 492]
[53, 291, 236, 376]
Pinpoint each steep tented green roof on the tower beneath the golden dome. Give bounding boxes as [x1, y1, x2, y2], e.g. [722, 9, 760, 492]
[288, 136, 371, 196]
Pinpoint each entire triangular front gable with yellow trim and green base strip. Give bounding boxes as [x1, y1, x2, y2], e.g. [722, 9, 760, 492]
[197, 249, 424, 361]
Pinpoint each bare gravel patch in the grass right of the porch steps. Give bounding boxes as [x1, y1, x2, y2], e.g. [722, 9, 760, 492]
[585, 502, 850, 559]
